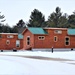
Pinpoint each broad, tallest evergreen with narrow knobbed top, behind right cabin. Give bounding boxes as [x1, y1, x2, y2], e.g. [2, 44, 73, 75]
[47, 7, 68, 27]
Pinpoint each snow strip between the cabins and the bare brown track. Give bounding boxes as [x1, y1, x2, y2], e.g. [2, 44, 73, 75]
[0, 51, 75, 60]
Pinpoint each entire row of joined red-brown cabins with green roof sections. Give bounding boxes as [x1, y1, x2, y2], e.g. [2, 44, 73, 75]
[0, 27, 75, 50]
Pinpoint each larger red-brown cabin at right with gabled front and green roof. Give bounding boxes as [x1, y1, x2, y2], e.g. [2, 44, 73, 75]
[22, 28, 75, 49]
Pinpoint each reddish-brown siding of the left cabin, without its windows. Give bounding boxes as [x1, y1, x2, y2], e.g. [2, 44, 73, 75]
[0, 34, 23, 50]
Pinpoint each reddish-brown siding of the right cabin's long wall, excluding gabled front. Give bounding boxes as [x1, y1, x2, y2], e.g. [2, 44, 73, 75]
[34, 29, 75, 48]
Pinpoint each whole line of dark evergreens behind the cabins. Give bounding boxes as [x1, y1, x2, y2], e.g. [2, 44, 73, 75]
[0, 7, 75, 33]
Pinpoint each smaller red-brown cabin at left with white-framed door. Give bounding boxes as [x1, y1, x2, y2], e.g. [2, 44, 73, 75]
[0, 33, 23, 50]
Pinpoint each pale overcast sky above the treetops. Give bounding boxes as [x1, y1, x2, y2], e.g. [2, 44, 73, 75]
[0, 0, 75, 26]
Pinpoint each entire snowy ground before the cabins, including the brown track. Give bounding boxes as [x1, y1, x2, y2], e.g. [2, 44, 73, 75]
[0, 51, 75, 75]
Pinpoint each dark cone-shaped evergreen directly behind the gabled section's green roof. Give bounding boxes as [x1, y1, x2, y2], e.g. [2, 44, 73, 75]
[27, 9, 45, 27]
